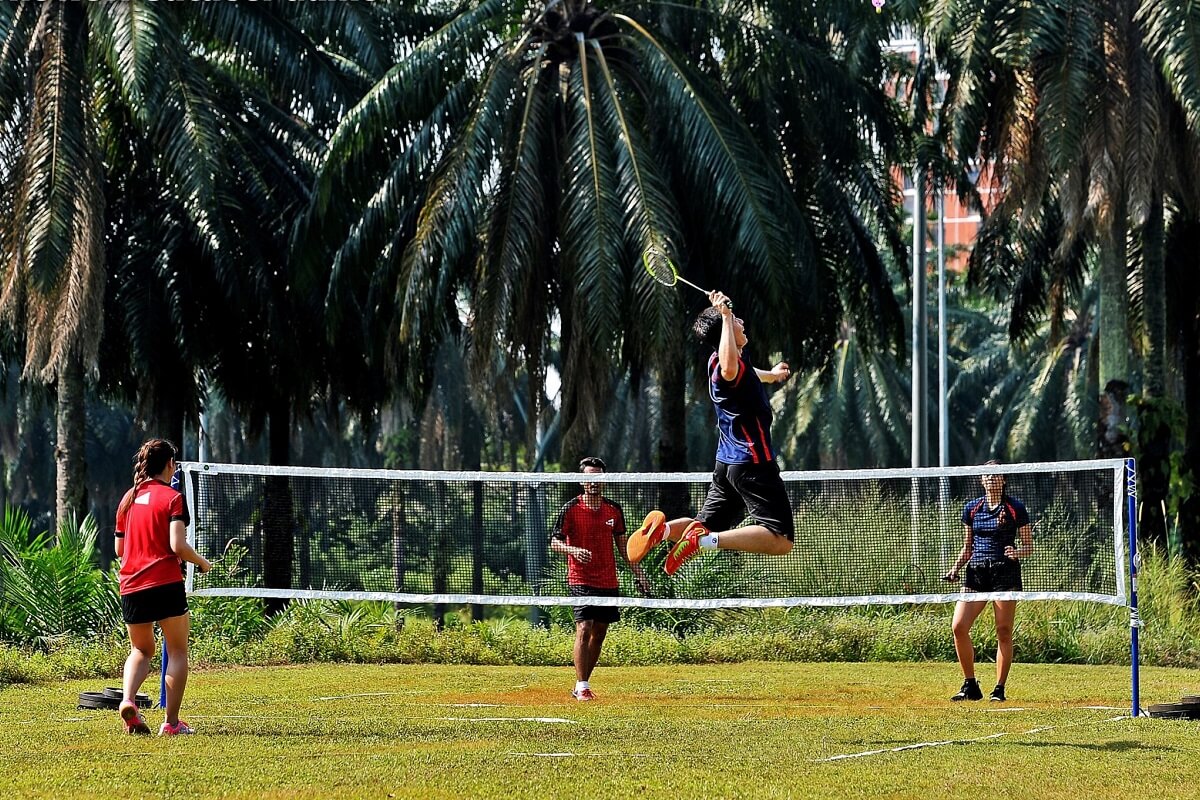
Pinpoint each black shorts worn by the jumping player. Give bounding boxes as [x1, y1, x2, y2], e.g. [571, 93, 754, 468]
[696, 462, 796, 542]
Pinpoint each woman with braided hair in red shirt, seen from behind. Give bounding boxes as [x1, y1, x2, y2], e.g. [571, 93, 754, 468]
[116, 439, 212, 736]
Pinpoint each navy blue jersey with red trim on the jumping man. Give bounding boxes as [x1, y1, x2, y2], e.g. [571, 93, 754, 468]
[708, 353, 775, 464]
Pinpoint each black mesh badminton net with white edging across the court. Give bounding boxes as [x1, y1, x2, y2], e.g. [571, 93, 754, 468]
[186, 464, 1123, 604]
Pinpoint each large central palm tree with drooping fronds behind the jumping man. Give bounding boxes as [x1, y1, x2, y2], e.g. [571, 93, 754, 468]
[308, 0, 900, 467]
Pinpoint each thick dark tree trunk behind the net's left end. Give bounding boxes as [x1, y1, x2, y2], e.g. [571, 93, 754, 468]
[263, 399, 295, 614]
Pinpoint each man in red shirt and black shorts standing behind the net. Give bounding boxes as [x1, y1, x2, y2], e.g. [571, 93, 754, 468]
[550, 456, 649, 700]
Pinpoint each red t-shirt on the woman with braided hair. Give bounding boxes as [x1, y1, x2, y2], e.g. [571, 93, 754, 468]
[116, 480, 184, 595]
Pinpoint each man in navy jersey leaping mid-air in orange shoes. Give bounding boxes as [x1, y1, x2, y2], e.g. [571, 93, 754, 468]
[626, 291, 796, 575]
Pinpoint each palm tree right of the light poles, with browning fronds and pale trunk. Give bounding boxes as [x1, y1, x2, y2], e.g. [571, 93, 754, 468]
[932, 0, 1176, 431]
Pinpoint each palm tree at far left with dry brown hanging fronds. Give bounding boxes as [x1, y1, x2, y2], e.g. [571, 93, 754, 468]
[0, 0, 370, 537]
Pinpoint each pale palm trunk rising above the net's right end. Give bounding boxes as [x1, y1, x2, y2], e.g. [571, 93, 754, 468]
[1097, 214, 1130, 458]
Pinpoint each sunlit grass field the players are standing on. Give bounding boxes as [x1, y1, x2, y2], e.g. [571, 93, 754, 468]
[0, 663, 1200, 800]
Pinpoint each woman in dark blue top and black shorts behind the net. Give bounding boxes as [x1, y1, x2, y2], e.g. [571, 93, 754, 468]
[944, 461, 1033, 702]
